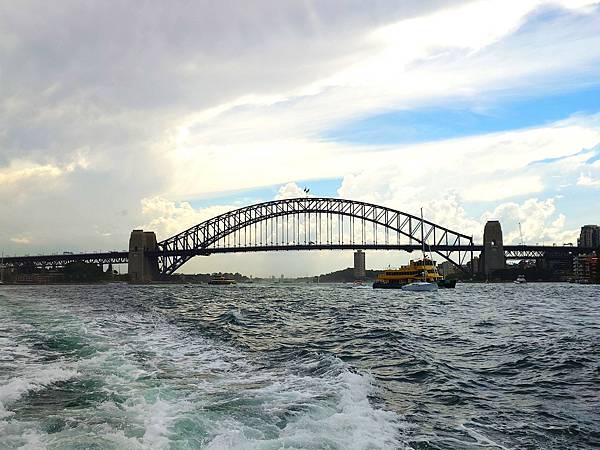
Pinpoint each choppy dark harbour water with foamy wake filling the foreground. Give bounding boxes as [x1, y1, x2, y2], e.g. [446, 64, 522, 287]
[0, 284, 600, 449]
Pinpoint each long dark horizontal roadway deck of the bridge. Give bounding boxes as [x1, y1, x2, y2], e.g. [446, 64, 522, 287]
[3, 243, 593, 267]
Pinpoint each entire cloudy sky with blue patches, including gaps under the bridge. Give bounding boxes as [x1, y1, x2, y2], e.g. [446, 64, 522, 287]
[0, 0, 600, 276]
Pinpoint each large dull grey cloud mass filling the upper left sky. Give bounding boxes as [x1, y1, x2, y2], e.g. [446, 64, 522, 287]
[0, 0, 464, 253]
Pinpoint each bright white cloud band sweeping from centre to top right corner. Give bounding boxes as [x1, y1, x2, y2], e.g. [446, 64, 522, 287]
[162, 2, 600, 196]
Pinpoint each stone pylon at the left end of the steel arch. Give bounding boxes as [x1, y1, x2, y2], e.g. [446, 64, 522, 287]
[127, 230, 160, 283]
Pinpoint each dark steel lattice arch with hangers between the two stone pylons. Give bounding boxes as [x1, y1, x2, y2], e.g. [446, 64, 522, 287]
[152, 197, 477, 275]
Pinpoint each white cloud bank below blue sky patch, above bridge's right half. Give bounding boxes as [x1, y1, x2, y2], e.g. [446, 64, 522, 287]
[339, 117, 600, 211]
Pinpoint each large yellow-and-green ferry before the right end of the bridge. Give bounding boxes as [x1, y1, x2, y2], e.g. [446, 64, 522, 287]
[373, 258, 456, 289]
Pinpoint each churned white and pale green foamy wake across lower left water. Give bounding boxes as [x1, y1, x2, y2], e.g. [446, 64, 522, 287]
[0, 294, 401, 450]
